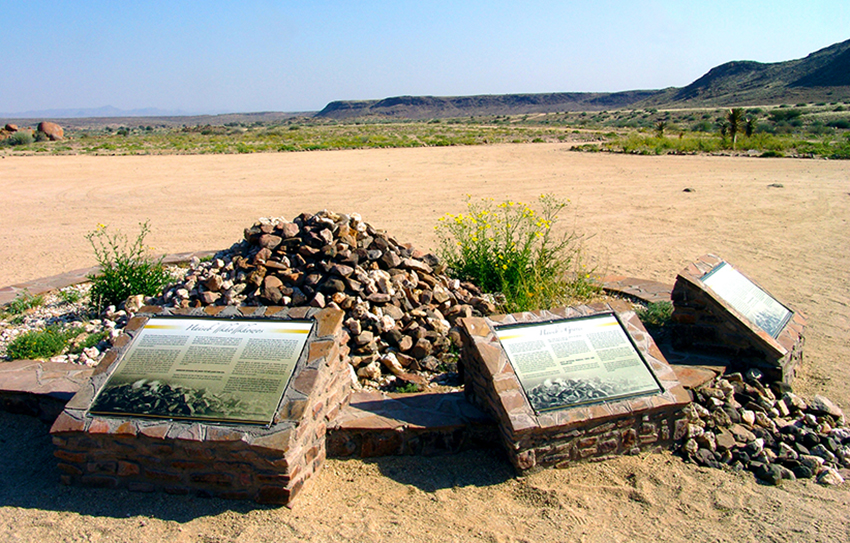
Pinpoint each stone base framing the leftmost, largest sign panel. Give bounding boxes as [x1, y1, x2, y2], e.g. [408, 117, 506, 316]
[50, 306, 351, 504]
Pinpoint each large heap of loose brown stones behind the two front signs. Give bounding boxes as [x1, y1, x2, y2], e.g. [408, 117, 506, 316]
[159, 211, 496, 388]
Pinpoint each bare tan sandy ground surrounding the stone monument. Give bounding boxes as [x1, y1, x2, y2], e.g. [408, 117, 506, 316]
[0, 144, 850, 542]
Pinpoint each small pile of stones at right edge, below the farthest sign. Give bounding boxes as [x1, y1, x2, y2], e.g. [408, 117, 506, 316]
[680, 370, 850, 485]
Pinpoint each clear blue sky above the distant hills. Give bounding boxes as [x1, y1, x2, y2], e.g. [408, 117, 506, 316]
[0, 0, 850, 113]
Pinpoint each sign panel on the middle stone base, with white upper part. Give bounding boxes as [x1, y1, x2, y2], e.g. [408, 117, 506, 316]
[496, 313, 663, 413]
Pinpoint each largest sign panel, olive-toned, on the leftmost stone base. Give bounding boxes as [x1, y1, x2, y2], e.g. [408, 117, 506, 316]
[89, 317, 313, 424]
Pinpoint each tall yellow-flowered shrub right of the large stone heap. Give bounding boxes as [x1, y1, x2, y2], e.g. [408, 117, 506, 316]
[435, 194, 598, 312]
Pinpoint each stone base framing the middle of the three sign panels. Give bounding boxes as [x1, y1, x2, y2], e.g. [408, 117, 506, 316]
[461, 301, 691, 473]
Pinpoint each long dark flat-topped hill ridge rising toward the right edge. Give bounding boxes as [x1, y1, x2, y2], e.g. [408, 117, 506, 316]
[316, 40, 850, 119]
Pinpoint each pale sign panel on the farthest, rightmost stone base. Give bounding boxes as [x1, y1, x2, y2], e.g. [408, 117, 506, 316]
[701, 262, 792, 338]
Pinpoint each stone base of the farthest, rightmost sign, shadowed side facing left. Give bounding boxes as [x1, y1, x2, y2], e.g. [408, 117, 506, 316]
[672, 255, 806, 385]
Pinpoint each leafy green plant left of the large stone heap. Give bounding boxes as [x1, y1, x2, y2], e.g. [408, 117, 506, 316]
[86, 222, 171, 311]
